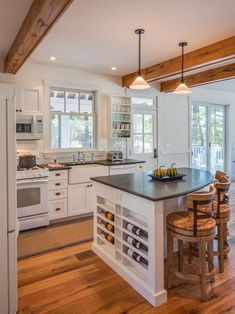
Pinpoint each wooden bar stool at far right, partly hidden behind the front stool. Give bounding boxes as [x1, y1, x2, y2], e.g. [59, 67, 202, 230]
[213, 176, 231, 273]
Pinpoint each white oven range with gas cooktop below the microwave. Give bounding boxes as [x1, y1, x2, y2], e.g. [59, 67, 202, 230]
[16, 166, 49, 231]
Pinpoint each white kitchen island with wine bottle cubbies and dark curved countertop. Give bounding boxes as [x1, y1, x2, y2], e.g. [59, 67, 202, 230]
[92, 168, 213, 306]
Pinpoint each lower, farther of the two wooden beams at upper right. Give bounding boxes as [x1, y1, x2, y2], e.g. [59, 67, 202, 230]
[161, 63, 235, 93]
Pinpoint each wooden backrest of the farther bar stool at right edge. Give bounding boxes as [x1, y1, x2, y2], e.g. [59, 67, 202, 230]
[214, 176, 231, 218]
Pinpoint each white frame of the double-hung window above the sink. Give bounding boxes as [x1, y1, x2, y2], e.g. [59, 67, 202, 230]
[47, 86, 98, 153]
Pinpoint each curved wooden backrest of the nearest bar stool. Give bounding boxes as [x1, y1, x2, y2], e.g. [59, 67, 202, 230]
[189, 185, 216, 236]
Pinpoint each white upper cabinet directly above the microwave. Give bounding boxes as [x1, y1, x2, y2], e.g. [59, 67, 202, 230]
[16, 86, 42, 113]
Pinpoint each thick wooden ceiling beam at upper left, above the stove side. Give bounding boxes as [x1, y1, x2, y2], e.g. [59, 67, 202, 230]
[4, 0, 73, 74]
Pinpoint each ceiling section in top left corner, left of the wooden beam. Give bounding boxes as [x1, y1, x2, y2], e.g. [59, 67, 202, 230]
[0, 0, 33, 58]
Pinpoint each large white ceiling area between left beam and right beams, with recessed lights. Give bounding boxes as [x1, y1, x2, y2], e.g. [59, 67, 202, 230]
[29, 0, 235, 75]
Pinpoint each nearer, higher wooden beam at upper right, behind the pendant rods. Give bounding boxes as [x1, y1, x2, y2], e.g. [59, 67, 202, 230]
[122, 36, 235, 87]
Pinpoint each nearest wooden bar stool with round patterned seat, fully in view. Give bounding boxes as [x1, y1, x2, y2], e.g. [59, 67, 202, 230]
[167, 186, 216, 301]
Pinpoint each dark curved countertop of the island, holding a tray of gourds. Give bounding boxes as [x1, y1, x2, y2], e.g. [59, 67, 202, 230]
[91, 168, 213, 201]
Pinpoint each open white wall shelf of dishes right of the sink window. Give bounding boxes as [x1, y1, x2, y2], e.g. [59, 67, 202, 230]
[110, 96, 131, 139]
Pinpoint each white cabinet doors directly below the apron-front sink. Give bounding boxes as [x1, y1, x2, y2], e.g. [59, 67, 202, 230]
[68, 182, 94, 216]
